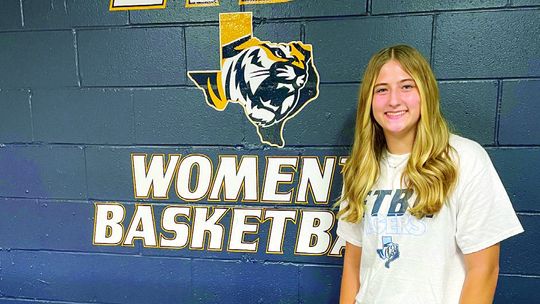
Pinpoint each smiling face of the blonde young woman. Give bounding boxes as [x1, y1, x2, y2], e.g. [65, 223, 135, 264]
[371, 60, 420, 142]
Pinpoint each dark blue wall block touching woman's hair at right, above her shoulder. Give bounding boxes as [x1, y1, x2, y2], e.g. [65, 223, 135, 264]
[439, 81, 498, 145]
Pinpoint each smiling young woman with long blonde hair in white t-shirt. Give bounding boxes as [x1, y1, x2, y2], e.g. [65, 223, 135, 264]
[337, 45, 523, 304]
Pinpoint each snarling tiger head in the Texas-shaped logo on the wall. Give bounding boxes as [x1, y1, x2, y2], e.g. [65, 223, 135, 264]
[188, 12, 319, 147]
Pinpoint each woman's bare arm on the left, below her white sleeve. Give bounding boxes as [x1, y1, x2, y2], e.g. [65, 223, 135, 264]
[339, 242, 362, 304]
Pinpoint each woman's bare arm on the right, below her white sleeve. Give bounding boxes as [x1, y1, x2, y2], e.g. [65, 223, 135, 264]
[460, 243, 500, 304]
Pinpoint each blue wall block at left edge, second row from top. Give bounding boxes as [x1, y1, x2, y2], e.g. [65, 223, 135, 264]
[0, 31, 77, 88]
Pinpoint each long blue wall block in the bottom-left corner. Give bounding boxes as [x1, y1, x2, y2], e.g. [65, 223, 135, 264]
[0, 251, 191, 303]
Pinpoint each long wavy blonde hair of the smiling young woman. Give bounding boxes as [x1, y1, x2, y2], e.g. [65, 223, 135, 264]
[338, 45, 457, 222]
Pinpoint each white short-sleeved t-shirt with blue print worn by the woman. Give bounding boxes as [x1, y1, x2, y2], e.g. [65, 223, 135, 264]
[337, 135, 523, 304]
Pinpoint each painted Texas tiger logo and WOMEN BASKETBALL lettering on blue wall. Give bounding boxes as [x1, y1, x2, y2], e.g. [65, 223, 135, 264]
[93, 6, 338, 257]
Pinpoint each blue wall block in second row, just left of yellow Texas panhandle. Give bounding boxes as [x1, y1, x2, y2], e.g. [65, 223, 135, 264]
[77, 27, 186, 86]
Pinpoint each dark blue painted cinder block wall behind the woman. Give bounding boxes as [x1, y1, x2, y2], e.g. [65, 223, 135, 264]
[0, 0, 540, 304]
